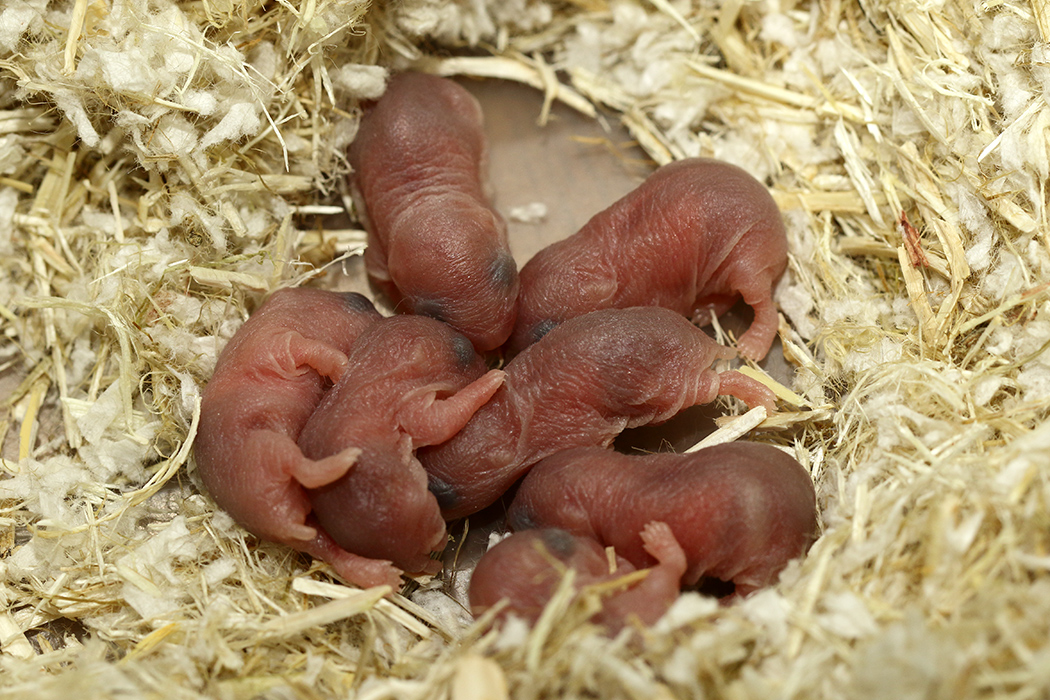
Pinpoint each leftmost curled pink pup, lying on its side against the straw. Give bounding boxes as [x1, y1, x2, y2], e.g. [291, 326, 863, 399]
[194, 289, 381, 575]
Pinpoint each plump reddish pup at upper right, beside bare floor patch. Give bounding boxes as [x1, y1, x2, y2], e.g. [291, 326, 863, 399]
[507, 158, 788, 360]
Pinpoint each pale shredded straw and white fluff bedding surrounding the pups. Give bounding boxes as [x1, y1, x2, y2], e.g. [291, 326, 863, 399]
[0, 0, 1050, 698]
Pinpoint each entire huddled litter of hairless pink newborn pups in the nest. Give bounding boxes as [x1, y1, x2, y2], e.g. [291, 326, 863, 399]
[196, 73, 816, 628]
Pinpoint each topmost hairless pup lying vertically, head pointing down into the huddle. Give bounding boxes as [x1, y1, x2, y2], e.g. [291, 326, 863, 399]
[349, 72, 519, 351]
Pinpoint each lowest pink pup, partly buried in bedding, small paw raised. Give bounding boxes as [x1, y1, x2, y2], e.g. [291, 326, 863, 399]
[469, 522, 686, 633]
